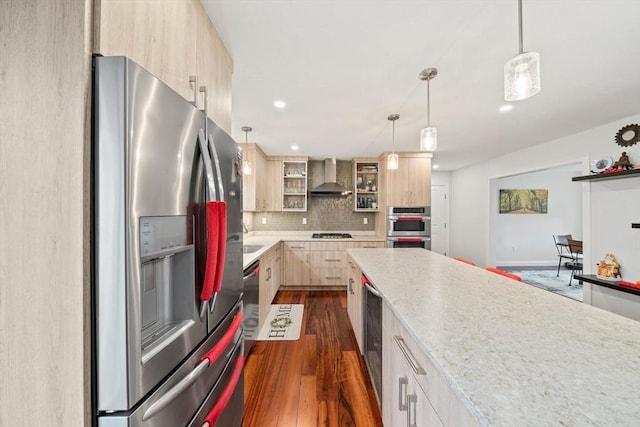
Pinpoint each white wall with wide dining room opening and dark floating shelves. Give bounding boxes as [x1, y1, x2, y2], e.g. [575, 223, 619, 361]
[450, 114, 640, 280]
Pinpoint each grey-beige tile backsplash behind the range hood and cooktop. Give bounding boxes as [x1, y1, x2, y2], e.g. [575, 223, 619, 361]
[244, 160, 375, 231]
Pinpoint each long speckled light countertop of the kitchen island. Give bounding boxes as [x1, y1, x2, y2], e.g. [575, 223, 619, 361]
[347, 249, 640, 427]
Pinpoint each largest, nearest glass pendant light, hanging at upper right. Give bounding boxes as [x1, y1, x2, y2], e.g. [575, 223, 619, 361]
[504, 0, 540, 101]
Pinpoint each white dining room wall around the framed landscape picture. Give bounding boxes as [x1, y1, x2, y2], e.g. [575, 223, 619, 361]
[489, 163, 582, 266]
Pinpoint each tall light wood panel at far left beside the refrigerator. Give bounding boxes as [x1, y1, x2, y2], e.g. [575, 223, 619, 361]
[0, 0, 92, 427]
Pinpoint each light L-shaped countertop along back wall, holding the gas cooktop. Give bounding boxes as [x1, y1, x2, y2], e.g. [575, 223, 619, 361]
[242, 231, 385, 269]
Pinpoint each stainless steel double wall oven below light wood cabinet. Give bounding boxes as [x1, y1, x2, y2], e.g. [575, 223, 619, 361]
[387, 206, 431, 249]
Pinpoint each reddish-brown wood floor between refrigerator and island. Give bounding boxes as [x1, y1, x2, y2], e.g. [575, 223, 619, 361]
[242, 291, 382, 427]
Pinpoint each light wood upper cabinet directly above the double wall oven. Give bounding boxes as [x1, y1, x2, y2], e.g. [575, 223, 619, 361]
[379, 153, 432, 207]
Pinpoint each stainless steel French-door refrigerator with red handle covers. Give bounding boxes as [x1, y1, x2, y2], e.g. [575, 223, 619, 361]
[91, 57, 244, 427]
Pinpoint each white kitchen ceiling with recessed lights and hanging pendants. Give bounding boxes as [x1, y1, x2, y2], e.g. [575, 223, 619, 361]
[202, 0, 640, 170]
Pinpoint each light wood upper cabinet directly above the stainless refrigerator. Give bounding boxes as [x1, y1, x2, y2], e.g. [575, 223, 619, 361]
[94, 0, 233, 134]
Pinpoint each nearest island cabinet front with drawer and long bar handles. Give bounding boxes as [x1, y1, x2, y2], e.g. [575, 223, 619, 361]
[382, 302, 478, 427]
